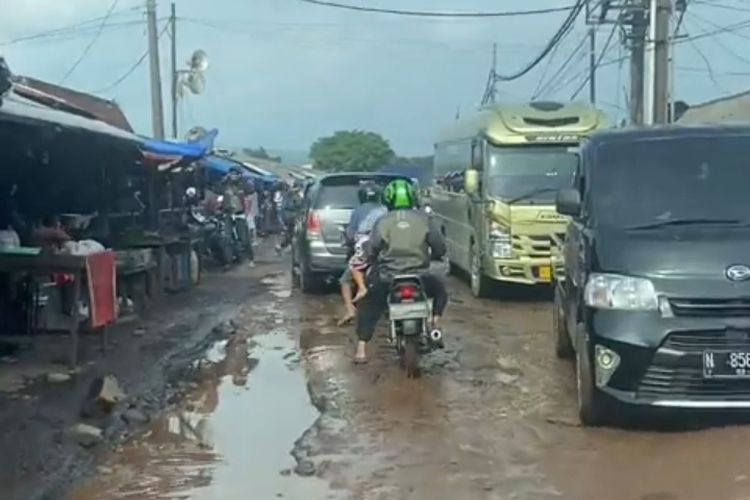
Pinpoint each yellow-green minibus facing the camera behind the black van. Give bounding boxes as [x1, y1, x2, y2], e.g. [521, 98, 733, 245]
[430, 102, 609, 297]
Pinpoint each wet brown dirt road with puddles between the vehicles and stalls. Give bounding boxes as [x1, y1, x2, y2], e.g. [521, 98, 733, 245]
[70, 262, 750, 500]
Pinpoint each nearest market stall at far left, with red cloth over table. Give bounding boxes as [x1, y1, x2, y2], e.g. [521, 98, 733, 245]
[0, 88, 140, 365]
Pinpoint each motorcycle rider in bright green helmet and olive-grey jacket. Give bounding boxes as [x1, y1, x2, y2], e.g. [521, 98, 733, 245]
[354, 179, 448, 363]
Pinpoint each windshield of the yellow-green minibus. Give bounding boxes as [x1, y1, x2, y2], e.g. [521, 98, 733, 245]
[486, 146, 578, 204]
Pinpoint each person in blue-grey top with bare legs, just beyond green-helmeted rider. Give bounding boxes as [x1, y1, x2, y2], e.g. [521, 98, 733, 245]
[339, 182, 388, 326]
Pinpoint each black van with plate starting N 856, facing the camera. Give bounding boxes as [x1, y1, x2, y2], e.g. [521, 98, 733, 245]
[554, 126, 750, 425]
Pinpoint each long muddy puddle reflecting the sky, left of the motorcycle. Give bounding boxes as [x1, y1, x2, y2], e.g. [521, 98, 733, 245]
[70, 289, 337, 500]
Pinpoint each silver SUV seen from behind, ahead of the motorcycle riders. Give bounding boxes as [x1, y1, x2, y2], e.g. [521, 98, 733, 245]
[292, 173, 415, 293]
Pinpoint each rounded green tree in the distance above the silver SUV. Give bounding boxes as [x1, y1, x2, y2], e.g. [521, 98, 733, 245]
[310, 130, 396, 172]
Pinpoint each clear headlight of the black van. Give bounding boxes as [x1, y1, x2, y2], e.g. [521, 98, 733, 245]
[584, 273, 659, 311]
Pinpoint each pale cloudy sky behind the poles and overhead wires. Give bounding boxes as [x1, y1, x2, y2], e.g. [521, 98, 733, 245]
[0, 0, 750, 155]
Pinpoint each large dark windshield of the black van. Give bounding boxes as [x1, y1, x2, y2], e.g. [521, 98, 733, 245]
[591, 135, 750, 228]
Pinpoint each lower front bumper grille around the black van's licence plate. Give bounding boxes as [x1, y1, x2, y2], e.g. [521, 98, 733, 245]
[637, 330, 750, 401]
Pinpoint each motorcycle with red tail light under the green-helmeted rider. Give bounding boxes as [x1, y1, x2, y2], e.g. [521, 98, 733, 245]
[388, 275, 443, 378]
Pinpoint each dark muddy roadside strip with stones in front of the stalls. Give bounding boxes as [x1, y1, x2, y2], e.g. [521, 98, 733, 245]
[0, 254, 274, 500]
